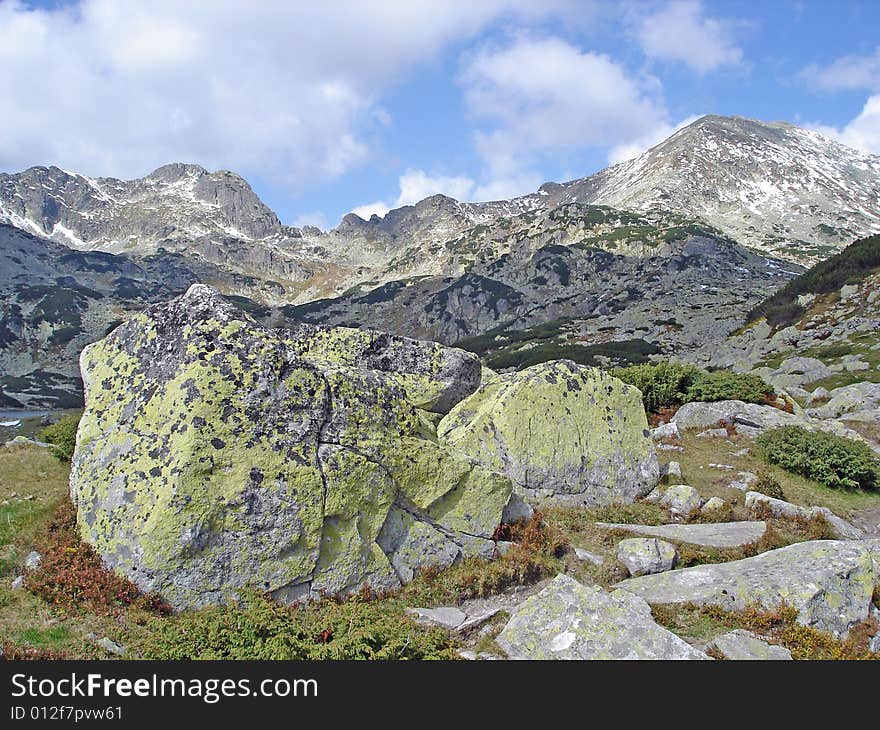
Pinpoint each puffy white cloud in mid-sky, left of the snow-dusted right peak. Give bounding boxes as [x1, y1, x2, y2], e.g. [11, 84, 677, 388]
[460, 36, 667, 185]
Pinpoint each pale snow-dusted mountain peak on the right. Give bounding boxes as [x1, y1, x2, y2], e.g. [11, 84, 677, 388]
[542, 116, 880, 262]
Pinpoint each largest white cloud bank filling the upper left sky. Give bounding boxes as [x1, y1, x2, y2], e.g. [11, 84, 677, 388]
[0, 0, 567, 188]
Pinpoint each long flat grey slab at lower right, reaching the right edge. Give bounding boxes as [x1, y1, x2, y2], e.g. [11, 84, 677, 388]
[617, 540, 878, 635]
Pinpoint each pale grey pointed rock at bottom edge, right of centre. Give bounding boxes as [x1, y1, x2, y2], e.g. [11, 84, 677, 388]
[496, 575, 708, 659]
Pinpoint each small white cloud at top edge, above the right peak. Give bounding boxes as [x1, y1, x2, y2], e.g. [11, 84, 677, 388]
[635, 0, 743, 75]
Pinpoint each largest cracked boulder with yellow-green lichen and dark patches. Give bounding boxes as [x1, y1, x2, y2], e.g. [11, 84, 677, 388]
[70, 285, 511, 608]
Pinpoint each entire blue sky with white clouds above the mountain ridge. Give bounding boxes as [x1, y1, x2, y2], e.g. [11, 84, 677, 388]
[0, 0, 880, 228]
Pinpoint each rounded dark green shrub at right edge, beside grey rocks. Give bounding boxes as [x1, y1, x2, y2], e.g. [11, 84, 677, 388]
[756, 426, 880, 489]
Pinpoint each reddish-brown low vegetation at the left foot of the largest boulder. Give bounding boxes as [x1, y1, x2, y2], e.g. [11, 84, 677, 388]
[25, 500, 170, 614]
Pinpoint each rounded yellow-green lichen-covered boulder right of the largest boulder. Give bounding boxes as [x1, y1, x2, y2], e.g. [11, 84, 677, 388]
[437, 360, 660, 506]
